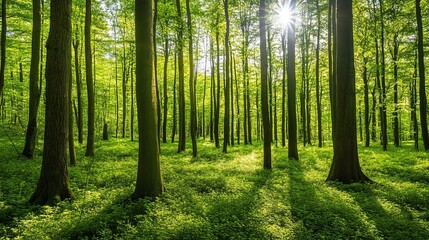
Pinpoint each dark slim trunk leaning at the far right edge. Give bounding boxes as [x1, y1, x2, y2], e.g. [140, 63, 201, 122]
[416, 0, 429, 151]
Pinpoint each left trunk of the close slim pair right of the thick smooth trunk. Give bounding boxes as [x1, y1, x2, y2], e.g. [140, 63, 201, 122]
[176, 0, 186, 152]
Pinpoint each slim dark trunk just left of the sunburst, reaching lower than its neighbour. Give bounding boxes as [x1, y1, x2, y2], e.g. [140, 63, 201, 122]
[259, 0, 271, 169]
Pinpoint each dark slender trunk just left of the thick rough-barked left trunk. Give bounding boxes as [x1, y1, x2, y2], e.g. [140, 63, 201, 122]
[22, 0, 41, 158]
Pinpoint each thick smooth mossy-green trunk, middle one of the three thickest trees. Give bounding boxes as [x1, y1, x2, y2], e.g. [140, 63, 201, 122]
[133, 0, 164, 197]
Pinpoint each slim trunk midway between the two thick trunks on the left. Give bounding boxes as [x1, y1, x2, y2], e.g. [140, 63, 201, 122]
[85, 0, 95, 157]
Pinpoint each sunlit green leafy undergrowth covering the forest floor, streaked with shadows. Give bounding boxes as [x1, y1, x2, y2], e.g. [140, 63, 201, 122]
[0, 134, 429, 239]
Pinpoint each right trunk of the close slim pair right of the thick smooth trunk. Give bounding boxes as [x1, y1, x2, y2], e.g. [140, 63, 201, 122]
[186, 0, 198, 157]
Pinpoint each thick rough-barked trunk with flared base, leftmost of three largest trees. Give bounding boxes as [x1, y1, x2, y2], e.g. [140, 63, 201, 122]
[29, 0, 72, 205]
